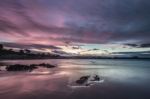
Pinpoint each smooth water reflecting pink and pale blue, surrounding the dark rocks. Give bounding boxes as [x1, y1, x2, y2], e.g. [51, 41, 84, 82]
[0, 59, 150, 99]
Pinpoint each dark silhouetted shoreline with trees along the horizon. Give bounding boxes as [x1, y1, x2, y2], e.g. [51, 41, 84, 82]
[0, 45, 150, 60]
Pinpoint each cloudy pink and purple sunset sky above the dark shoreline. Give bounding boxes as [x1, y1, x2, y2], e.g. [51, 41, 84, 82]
[0, 0, 150, 57]
